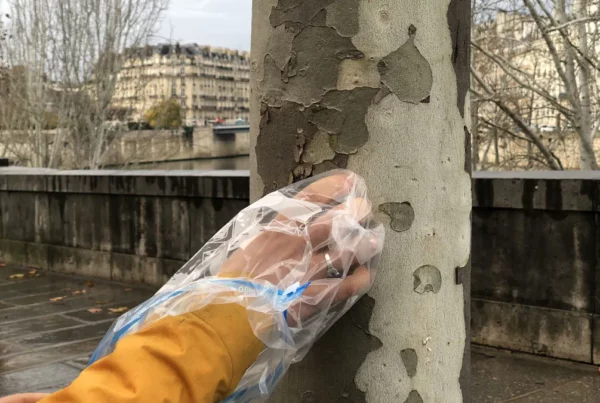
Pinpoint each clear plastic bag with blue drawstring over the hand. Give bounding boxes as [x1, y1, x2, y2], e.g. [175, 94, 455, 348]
[90, 170, 384, 403]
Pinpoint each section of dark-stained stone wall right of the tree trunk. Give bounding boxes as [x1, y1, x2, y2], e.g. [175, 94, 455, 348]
[472, 171, 600, 364]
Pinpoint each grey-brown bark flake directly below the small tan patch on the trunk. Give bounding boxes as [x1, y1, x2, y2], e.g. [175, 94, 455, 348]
[322, 87, 377, 154]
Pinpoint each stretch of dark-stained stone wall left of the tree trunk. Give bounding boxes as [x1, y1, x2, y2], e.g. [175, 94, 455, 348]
[0, 168, 249, 285]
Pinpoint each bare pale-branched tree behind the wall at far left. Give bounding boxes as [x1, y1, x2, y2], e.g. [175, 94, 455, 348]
[0, 0, 168, 168]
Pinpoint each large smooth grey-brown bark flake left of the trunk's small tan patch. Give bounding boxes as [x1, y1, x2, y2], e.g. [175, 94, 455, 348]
[283, 26, 364, 106]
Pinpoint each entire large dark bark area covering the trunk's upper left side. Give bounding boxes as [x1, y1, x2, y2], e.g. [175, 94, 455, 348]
[256, 0, 381, 185]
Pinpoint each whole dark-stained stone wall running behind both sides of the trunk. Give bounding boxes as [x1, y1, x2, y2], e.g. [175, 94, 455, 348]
[0, 168, 600, 364]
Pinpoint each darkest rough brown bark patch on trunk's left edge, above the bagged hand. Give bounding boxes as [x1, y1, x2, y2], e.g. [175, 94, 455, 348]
[256, 102, 317, 194]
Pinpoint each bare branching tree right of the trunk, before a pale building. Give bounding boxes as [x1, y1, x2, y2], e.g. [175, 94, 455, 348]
[472, 0, 600, 169]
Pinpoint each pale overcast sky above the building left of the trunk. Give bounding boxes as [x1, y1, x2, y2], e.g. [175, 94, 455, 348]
[154, 0, 252, 50]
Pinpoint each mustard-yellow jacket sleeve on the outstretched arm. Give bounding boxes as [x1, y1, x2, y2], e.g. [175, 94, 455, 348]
[41, 304, 264, 403]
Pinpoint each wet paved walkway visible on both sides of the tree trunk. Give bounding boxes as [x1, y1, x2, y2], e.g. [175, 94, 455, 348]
[0, 265, 600, 403]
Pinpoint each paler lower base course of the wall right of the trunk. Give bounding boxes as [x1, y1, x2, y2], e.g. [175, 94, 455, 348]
[471, 299, 598, 363]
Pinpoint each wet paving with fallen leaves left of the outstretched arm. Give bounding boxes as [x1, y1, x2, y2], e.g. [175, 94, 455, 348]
[0, 265, 153, 396]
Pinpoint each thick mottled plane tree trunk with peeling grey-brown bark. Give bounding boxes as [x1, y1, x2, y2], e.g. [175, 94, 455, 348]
[251, 0, 471, 403]
